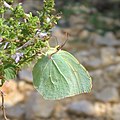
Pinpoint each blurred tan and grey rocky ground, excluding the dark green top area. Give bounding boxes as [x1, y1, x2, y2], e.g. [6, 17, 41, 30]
[0, 0, 120, 120]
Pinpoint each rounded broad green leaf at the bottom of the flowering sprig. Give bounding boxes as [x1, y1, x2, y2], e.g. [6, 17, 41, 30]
[4, 64, 16, 80]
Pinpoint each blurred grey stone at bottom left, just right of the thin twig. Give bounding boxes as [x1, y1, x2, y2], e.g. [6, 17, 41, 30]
[6, 104, 25, 120]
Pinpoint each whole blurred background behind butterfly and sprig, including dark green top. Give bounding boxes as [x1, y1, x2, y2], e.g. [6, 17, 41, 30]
[0, 0, 120, 120]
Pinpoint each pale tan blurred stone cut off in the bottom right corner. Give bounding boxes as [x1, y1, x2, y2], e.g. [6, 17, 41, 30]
[112, 103, 120, 120]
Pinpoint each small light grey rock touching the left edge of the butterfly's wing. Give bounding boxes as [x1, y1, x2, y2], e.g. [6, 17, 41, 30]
[19, 69, 33, 83]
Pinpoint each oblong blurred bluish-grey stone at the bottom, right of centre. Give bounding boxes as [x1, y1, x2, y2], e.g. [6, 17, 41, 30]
[67, 100, 95, 116]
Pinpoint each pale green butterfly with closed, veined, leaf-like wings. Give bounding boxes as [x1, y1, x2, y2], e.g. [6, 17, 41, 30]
[33, 49, 92, 100]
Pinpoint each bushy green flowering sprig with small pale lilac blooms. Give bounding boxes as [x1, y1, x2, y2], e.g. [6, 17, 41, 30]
[0, 0, 60, 86]
